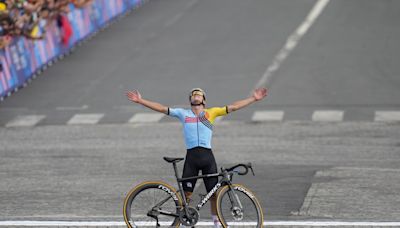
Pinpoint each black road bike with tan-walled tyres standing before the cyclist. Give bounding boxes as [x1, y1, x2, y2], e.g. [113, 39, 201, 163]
[123, 157, 264, 228]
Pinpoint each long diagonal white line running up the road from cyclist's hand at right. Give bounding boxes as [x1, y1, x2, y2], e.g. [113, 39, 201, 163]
[250, 0, 329, 91]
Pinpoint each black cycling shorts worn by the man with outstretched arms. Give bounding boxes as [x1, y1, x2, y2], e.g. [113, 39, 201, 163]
[182, 147, 218, 192]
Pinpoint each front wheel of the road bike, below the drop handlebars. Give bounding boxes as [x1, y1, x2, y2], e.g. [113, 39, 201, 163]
[217, 184, 264, 228]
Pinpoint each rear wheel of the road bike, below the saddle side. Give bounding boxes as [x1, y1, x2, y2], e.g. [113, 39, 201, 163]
[123, 182, 182, 228]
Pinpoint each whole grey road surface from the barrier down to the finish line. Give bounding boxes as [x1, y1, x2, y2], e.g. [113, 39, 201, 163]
[0, 0, 400, 226]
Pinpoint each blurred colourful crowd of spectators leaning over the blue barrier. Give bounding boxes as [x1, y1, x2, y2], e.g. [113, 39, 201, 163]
[0, 0, 93, 49]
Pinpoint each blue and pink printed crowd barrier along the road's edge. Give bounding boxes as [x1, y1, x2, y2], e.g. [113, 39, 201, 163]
[0, 0, 146, 100]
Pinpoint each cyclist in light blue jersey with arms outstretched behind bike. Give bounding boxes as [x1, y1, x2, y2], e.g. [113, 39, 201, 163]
[126, 88, 267, 227]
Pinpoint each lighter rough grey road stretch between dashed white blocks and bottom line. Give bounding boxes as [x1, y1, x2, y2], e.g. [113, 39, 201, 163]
[0, 122, 400, 224]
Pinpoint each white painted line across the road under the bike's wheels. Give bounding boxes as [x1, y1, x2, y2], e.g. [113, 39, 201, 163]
[0, 221, 400, 227]
